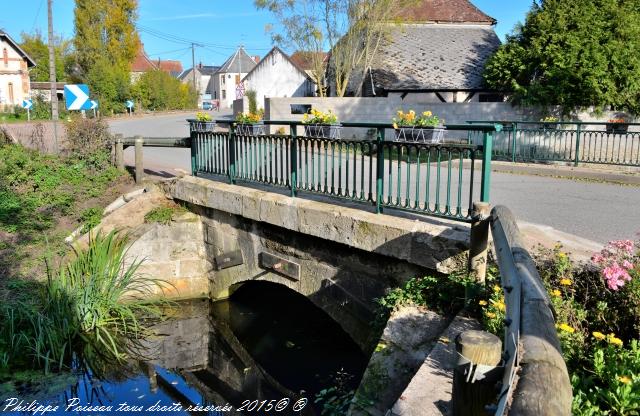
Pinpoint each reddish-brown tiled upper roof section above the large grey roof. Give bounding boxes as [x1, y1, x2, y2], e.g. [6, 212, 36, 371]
[394, 0, 496, 25]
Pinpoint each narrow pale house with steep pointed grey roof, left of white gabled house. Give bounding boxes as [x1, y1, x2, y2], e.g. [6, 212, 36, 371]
[209, 46, 260, 108]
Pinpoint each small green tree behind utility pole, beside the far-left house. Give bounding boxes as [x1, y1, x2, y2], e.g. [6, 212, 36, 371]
[20, 31, 73, 82]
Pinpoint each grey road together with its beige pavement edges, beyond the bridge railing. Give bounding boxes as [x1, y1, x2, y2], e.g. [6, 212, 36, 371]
[109, 110, 640, 245]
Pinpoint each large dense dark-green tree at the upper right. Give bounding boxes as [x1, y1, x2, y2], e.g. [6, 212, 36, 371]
[484, 0, 640, 114]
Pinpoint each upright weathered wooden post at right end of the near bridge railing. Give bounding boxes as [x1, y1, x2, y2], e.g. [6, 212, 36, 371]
[468, 202, 491, 283]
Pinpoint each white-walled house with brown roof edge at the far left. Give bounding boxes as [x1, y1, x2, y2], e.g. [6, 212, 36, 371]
[0, 31, 36, 111]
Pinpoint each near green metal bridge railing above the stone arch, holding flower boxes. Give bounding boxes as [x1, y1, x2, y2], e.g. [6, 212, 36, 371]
[191, 120, 499, 222]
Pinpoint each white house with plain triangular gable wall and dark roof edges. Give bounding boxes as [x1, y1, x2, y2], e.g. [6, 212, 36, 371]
[242, 46, 316, 109]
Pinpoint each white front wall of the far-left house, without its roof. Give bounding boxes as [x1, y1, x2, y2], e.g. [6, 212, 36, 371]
[0, 40, 30, 106]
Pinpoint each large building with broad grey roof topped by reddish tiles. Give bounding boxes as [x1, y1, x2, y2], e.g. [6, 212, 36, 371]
[350, 0, 503, 102]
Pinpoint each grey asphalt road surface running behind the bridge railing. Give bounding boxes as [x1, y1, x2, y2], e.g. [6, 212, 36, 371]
[110, 113, 640, 243]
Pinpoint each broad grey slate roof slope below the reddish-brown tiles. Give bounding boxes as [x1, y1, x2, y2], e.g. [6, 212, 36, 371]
[371, 24, 500, 91]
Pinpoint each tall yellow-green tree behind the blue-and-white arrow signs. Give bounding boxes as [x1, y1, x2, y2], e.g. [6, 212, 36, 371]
[74, 0, 140, 111]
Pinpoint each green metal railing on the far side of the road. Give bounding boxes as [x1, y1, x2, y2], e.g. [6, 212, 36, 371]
[468, 121, 640, 166]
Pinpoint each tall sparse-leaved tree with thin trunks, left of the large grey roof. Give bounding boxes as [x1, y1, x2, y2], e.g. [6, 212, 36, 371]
[254, 0, 417, 96]
